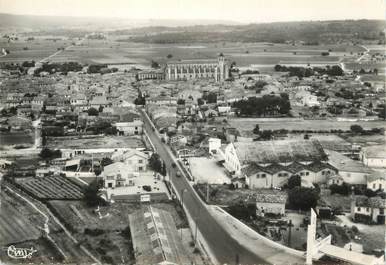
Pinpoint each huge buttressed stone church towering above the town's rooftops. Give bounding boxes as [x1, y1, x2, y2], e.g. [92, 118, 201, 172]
[165, 56, 229, 82]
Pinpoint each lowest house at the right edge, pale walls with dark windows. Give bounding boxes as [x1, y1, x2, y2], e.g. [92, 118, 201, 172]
[351, 195, 386, 225]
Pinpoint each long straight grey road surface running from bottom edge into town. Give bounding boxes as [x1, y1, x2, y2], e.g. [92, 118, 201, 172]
[140, 110, 268, 265]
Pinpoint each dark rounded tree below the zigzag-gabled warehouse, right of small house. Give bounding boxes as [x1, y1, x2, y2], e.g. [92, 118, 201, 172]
[288, 187, 319, 211]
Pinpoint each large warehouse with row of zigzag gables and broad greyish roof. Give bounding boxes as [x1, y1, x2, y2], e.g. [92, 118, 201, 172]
[220, 140, 338, 189]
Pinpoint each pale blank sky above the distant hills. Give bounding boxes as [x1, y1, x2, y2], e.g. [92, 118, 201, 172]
[0, 0, 386, 23]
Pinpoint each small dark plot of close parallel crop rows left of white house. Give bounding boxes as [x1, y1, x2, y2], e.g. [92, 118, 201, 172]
[17, 176, 83, 200]
